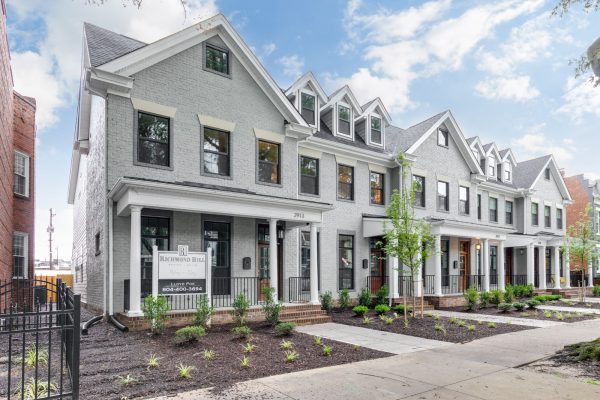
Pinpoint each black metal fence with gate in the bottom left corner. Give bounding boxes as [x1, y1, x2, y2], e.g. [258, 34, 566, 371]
[0, 279, 80, 400]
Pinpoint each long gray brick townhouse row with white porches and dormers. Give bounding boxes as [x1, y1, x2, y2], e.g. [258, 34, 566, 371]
[68, 15, 570, 317]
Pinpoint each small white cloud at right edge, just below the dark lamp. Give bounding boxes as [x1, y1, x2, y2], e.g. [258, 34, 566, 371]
[557, 77, 600, 123]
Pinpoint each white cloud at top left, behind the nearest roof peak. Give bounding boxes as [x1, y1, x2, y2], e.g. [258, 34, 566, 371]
[9, 0, 217, 131]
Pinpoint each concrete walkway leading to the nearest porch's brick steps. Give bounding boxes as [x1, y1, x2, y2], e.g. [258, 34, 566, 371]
[297, 322, 451, 354]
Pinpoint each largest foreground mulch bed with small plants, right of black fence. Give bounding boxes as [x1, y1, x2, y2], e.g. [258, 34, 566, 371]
[71, 310, 391, 400]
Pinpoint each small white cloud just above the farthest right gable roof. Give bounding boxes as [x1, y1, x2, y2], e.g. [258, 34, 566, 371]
[511, 123, 576, 165]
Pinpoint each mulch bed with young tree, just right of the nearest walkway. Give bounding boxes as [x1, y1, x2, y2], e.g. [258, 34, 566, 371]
[331, 310, 532, 343]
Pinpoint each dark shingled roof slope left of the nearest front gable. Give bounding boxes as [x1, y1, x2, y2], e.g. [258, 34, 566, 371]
[83, 22, 146, 67]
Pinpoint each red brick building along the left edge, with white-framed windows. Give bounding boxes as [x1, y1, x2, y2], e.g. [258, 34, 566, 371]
[0, 0, 35, 281]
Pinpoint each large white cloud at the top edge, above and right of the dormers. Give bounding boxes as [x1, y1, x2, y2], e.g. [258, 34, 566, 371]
[331, 0, 544, 113]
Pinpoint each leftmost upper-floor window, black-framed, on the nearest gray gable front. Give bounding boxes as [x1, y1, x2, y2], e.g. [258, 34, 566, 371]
[137, 111, 171, 167]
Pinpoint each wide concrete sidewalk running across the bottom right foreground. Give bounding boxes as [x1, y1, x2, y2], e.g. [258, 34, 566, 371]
[154, 320, 600, 400]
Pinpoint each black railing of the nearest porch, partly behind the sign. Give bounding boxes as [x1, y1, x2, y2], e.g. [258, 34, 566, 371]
[123, 276, 268, 311]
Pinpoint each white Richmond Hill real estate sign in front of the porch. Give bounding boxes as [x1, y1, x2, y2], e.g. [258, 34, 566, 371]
[152, 246, 210, 295]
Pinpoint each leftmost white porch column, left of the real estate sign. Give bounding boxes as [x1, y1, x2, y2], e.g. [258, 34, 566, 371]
[127, 206, 142, 316]
